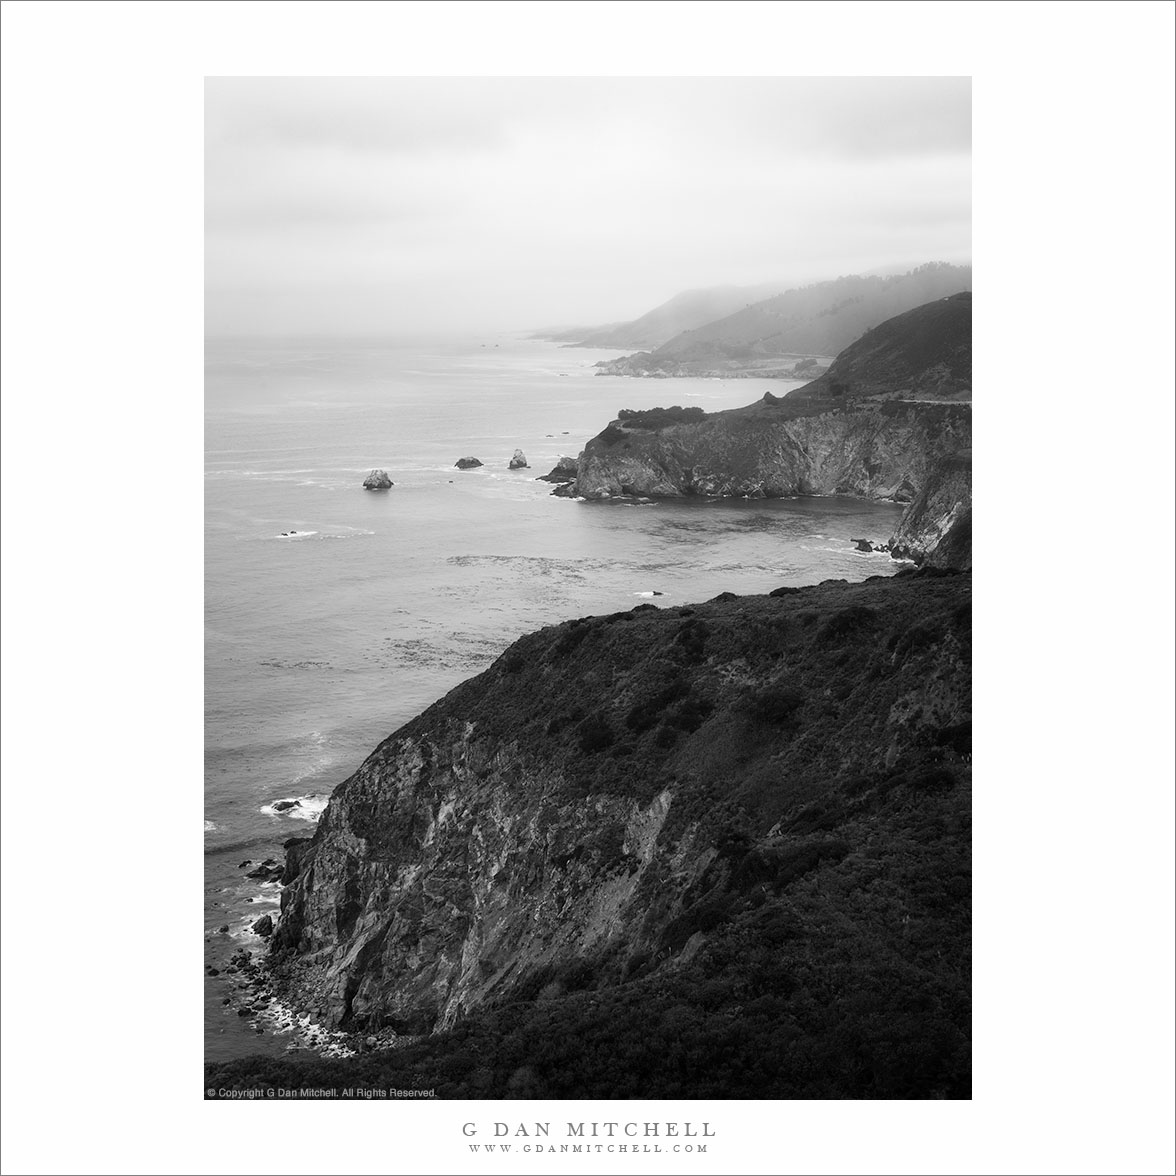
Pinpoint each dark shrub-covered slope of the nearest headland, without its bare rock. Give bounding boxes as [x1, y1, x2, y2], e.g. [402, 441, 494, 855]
[207, 569, 971, 1098]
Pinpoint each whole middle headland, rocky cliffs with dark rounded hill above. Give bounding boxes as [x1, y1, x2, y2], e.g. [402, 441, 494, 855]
[566, 292, 971, 568]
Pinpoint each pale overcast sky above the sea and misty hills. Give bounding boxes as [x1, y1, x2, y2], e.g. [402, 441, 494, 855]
[206, 78, 971, 334]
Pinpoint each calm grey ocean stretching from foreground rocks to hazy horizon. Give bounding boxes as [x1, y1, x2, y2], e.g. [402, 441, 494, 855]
[205, 336, 901, 1061]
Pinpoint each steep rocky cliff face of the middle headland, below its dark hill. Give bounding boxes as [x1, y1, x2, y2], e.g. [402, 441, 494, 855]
[576, 393, 971, 502]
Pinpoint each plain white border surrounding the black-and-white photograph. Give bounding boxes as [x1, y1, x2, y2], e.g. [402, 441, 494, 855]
[2, 0, 1174, 1172]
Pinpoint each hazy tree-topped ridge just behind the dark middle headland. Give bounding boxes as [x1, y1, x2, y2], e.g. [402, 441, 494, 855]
[600, 262, 971, 375]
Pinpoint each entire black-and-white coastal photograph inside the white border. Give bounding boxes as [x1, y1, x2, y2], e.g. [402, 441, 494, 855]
[205, 78, 973, 1100]
